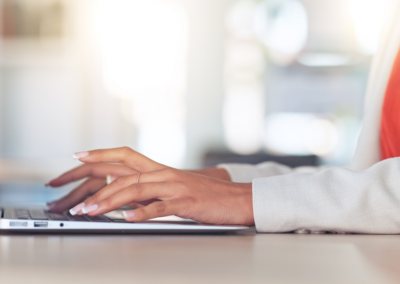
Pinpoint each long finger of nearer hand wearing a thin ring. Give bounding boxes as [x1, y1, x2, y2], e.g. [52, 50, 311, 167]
[81, 170, 170, 207]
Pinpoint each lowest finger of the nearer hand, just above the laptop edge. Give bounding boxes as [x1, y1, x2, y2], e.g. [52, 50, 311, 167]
[122, 199, 185, 222]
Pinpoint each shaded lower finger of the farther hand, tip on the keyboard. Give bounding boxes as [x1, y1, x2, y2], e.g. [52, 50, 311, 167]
[49, 178, 106, 212]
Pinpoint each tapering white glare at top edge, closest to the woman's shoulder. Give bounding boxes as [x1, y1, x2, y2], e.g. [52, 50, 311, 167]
[350, 0, 389, 55]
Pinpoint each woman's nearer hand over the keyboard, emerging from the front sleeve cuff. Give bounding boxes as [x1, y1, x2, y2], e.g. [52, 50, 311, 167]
[67, 147, 254, 225]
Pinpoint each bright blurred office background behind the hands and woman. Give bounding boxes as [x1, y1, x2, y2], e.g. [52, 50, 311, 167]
[0, 0, 396, 190]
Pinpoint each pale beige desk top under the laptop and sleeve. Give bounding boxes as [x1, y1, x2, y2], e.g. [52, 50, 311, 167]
[0, 230, 400, 284]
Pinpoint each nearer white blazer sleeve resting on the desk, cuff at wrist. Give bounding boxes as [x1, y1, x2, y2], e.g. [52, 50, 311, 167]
[253, 158, 400, 234]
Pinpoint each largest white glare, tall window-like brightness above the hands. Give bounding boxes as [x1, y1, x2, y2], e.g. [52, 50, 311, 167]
[97, 0, 188, 167]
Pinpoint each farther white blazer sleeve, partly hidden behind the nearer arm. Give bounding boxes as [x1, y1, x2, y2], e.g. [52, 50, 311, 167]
[217, 162, 324, 183]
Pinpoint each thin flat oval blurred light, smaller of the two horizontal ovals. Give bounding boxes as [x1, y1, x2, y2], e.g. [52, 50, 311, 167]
[297, 52, 353, 67]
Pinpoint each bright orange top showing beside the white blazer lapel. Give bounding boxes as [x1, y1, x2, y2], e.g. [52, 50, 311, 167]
[380, 51, 400, 160]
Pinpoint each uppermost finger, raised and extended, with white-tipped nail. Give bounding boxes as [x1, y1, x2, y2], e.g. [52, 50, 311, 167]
[74, 147, 167, 172]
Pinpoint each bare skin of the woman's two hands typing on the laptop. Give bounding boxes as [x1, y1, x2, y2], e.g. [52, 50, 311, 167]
[48, 147, 254, 226]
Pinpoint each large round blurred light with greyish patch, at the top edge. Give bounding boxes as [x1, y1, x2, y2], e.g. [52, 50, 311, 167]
[254, 0, 308, 65]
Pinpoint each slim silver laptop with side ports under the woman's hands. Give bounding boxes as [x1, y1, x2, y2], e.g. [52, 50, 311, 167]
[0, 207, 248, 234]
